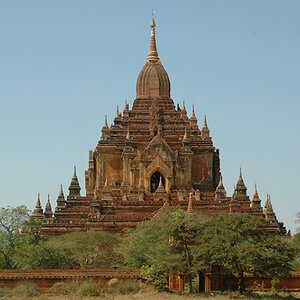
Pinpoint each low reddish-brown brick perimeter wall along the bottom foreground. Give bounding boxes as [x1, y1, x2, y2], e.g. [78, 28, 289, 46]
[0, 269, 300, 292]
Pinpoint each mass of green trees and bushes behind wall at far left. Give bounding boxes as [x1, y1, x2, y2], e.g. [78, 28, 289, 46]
[0, 206, 120, 269]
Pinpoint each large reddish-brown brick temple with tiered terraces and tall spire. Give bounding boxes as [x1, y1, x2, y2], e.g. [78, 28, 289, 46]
[33, 18, 286, 236]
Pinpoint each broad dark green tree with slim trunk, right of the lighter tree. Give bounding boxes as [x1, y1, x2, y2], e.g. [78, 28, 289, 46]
[194, 214, 295, 291]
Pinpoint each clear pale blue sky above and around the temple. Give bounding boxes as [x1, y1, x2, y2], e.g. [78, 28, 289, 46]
[0, 0, 300, 231]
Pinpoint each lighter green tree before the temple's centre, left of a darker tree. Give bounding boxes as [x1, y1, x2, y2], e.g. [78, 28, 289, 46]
[122, 208, 203, 290]
